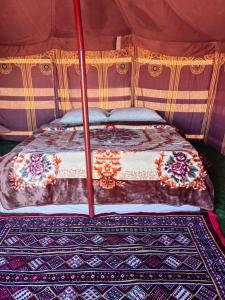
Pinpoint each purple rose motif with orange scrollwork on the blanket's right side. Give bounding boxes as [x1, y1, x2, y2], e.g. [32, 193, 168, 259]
[155, 151, 207, 191]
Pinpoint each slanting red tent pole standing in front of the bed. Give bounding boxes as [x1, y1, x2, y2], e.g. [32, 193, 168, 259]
[73, 0, 94, 218]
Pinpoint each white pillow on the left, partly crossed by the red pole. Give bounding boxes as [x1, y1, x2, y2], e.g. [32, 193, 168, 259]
[59, 107, 108, 125]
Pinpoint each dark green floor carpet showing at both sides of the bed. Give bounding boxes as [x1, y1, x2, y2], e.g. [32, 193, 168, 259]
[0, 141, 225, 234]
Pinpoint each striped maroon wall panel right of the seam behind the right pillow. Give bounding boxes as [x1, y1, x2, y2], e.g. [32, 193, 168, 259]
[134, 49, 214, 139]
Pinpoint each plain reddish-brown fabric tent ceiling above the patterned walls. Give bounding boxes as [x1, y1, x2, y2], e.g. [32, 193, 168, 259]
[0, 0, 225, 52]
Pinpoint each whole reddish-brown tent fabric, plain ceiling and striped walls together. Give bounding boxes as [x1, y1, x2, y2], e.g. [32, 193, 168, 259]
[0, 0, 225, 153]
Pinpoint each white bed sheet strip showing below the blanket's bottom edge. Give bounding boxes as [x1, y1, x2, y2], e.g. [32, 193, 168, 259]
[0, 204, 200, 215]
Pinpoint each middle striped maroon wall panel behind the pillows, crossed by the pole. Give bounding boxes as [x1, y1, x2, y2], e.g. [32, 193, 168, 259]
[56, 48, 133, 115]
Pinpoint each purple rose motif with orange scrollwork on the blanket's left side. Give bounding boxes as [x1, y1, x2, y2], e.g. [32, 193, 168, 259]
[9, 153, 61, 190]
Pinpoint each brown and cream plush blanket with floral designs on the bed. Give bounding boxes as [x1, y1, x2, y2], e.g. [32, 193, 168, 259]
[0, 124, 213, 209]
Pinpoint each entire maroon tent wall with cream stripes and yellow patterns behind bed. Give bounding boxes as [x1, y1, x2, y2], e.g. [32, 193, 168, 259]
[0, 47, 225, 153]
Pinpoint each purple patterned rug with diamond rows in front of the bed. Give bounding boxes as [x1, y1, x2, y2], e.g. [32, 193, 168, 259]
[0, 214, 225, 300]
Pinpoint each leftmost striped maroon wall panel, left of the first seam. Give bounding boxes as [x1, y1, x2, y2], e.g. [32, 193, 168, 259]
[0, 57, 55, 140]
